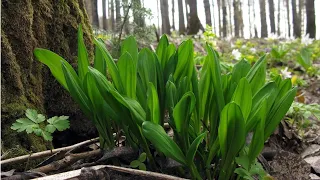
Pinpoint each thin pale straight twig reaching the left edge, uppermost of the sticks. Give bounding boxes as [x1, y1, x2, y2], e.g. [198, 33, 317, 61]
[0, 138, 99, 167]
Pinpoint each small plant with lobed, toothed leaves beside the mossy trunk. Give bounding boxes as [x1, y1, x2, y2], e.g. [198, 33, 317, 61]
[11, 109, 70, 141]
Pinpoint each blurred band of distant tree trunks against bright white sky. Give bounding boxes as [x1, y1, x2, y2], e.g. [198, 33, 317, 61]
[85, 0, 320, 39]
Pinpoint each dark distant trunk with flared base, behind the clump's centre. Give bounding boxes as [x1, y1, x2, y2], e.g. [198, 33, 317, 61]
[188, 0, 204, 35]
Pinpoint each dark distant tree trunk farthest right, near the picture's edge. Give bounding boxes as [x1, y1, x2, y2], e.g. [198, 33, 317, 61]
[306, 0, 316, 38]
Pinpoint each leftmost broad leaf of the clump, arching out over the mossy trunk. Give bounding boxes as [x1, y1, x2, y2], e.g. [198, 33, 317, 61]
[33, 48, 77, 90]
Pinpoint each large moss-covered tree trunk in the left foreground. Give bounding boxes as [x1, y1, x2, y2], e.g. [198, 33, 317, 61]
[1, 0, 96, 171]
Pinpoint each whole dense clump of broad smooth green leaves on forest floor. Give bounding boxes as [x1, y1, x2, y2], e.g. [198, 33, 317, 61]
[35, 24, 296, 179]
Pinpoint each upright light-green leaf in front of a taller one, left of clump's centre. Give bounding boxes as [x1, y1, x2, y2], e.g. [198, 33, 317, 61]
[117, 52, 137, 99]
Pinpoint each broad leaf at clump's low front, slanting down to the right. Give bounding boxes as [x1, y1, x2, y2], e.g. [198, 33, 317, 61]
[142, 121, 187, 165]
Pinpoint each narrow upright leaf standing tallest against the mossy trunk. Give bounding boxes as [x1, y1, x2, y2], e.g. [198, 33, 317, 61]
[78, 24, 89, 80]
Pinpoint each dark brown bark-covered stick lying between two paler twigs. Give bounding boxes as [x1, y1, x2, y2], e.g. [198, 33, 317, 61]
[29, 149, 102, 173]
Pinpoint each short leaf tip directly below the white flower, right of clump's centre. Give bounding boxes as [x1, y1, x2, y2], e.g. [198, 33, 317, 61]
[231, 59, 251, 84]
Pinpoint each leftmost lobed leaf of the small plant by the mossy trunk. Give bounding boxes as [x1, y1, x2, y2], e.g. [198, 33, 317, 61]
[11, 118, 40, 134]
